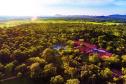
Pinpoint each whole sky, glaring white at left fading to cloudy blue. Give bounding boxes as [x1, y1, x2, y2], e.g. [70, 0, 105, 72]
[0, 0, 126, 16]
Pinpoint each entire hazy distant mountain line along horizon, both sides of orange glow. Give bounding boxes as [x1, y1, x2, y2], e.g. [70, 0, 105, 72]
[0, 14, 126, 23]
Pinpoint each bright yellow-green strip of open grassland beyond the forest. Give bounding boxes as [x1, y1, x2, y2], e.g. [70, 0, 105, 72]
[0, 19, 119, 28]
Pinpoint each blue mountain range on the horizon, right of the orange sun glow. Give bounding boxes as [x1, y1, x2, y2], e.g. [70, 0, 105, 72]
[44, 14, 126, 23]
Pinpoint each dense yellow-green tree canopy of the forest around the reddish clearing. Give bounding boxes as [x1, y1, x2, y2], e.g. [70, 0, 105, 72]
[0, 22, 126, 84]
